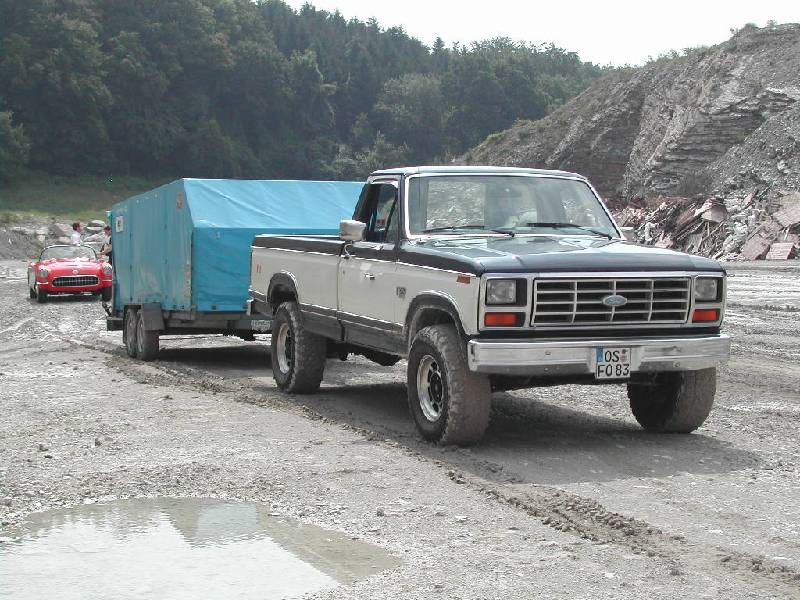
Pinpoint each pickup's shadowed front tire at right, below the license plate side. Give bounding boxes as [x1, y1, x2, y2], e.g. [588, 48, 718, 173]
[628, 369, 717, 433]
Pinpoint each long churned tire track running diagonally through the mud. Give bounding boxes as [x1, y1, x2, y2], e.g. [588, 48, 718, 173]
[81, 340, 800, 597]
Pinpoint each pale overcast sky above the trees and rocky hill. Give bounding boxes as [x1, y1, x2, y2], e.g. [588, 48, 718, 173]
[288, 0, 800, 65]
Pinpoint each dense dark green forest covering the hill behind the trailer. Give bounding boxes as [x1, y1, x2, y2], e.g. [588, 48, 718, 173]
[0, 0, 600, 183]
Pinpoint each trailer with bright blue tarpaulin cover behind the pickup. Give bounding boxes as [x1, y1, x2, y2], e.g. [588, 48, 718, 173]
[106, 179, 363, 360]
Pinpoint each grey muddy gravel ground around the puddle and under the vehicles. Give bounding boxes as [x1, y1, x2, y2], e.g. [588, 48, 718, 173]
[0, 261, 800, 599]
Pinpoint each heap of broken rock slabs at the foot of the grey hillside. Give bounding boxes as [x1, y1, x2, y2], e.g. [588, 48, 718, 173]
[616, 192, 800, 260]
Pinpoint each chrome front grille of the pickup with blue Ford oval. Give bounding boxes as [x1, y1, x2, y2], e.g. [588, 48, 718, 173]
[531, 277, 691, 327]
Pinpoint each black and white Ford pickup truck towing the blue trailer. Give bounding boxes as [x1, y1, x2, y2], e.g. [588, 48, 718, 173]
[249, 167, 730, 444]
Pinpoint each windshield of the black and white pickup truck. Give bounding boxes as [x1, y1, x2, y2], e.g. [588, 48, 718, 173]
[408, 175, 618, 238]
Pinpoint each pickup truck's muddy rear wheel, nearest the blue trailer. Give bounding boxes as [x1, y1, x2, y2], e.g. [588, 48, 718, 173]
[270, 302, 327, 394]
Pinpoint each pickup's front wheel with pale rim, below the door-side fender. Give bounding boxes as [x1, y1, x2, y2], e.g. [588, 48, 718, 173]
[408, 325, 492, 445]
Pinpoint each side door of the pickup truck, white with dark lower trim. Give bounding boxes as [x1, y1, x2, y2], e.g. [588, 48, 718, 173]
[338, 180, 402, 349]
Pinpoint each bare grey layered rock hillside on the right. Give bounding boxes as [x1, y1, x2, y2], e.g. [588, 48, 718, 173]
[461, 24, 800, 199]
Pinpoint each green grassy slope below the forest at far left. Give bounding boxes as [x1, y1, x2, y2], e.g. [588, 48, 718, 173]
[0, 172, 166, 221]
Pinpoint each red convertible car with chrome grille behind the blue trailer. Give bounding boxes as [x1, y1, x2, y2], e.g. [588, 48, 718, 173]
[28, 246, 112, 302]
